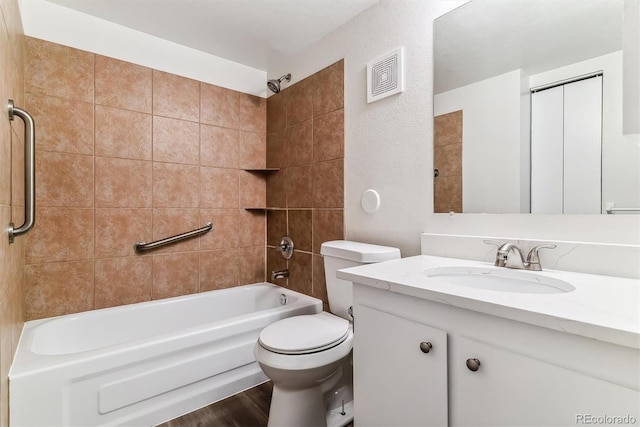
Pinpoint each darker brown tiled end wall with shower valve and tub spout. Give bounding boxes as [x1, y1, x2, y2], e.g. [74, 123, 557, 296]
[266, 60, 344, 308]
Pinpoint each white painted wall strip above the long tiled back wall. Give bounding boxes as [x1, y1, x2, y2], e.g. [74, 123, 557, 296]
[20, 0, 267, 97]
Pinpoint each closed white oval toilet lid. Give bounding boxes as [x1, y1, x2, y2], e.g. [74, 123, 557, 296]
[259, 312, 349, 354]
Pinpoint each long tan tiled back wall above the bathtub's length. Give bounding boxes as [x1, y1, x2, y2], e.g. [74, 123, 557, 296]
[24, 38, 267, 319]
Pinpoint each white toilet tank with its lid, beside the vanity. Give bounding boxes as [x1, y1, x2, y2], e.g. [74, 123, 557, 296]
[320, 240, 400, 320]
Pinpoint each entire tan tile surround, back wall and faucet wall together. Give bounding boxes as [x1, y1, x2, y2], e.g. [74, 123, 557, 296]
[24, 38, 344, 320]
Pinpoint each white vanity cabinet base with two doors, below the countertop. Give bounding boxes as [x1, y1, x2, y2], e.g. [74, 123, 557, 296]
[354, 284, 640, 427]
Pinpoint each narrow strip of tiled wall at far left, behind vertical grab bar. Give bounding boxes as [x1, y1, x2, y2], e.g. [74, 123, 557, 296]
[0, 0, 25, 427]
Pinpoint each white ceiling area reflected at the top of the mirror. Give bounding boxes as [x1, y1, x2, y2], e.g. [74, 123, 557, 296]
[434, 0, 624, 93]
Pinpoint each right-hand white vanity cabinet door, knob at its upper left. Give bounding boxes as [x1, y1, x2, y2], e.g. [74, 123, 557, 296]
[449, 336, 640, 427]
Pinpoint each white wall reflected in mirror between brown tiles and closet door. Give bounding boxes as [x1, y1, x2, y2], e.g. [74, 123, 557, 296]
[433, 70, 529, 213]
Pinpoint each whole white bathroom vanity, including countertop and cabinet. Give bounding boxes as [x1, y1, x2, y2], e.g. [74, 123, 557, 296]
[338, 255, 640, 427]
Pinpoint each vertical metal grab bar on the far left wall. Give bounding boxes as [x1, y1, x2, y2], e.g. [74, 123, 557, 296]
[8, 99, 36, 243]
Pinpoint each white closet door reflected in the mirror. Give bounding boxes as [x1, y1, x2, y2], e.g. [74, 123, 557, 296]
[531, 75, 602, 214]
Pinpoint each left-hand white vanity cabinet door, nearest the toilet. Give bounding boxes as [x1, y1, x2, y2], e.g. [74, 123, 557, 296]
[353, 305, 448, 427]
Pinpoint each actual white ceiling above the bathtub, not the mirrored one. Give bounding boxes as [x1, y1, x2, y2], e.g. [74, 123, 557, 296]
[48, 0, 379, 70]
